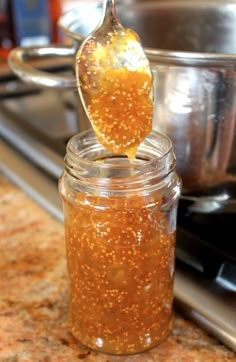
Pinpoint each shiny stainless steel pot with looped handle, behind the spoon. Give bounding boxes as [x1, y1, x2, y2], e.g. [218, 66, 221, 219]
[9, 0, 236, 191]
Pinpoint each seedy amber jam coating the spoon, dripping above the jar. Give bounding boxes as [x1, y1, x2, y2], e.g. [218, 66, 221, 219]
[79, 29, 153, 160]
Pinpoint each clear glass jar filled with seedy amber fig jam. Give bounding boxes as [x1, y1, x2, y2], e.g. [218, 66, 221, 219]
[59, 130, 181, 354]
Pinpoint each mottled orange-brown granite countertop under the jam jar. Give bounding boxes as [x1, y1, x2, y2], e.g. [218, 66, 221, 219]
[0, 174, 236, 362]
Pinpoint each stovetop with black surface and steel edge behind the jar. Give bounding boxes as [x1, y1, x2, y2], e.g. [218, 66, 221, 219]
[0, 73, 236, 350]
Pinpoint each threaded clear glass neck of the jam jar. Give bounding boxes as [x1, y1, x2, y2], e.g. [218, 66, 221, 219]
[65, 130, 176, 194]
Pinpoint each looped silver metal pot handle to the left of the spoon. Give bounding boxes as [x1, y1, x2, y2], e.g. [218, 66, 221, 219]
[8, 45, 76, 89]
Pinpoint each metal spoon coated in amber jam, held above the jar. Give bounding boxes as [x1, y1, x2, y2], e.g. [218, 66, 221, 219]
[76, 0, 153, 159]
